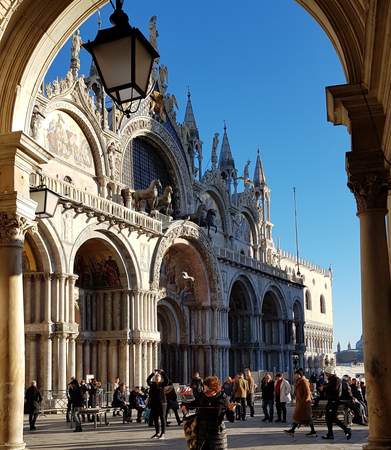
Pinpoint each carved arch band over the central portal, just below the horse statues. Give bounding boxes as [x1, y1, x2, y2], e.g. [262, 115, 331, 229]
[150, 220, 222, 303]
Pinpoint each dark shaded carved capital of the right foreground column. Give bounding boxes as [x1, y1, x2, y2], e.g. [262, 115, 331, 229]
[346, 150, 391, 215]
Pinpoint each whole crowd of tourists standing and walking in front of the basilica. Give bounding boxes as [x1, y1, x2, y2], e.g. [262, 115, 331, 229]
[26, 368, 367, 450]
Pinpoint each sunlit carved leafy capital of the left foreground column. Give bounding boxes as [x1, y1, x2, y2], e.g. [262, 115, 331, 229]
[0, 212, 36, 246]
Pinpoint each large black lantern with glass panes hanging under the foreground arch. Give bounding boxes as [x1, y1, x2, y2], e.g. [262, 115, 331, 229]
[83, 0, 159, 113]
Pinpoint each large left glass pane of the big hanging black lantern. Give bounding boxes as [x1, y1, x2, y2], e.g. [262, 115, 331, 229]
[94, 36, 132, 90]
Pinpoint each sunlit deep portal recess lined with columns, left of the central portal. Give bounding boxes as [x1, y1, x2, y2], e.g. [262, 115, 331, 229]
[73, 237, 135, 390]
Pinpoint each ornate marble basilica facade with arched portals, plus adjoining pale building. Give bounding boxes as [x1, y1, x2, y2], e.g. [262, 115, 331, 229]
[23, 21, 333, 392]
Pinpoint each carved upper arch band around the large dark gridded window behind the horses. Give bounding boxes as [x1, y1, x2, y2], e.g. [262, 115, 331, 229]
[121, 116, 192, 208]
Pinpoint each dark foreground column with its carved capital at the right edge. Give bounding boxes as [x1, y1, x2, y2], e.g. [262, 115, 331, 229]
[347, 150, 391, 450]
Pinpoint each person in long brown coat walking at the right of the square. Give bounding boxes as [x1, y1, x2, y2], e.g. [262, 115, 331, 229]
[284, 369, 316, 437]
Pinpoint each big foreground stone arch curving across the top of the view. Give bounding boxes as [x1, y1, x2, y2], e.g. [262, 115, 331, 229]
[0, 0, 365, 132]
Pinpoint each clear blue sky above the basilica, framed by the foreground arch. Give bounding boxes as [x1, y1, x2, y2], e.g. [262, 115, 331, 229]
[46, 0, 361, 348]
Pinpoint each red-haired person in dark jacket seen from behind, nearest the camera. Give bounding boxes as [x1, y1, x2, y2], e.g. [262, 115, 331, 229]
[182, 376, 235, 450]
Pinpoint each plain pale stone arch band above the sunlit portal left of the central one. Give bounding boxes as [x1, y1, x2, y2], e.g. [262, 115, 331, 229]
[69, 224, 141, 288]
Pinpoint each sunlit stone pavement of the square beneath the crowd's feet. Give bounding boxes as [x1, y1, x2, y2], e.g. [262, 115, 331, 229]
[25, 415, 368, 450]
